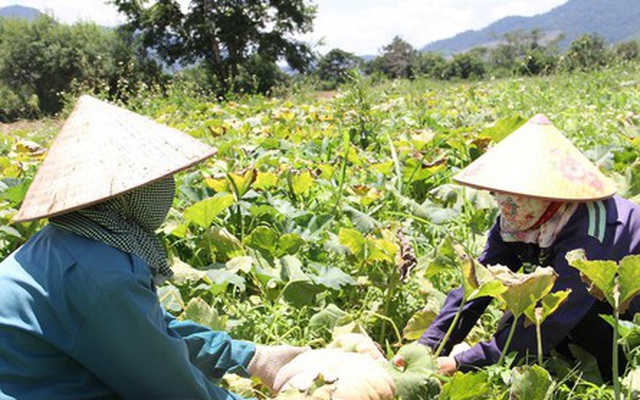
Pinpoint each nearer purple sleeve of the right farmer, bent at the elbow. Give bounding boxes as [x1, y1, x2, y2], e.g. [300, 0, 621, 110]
[455, 237, 606, 372]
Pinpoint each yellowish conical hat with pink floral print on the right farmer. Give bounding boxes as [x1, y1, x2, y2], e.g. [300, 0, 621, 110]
[453, 114, 616, 202]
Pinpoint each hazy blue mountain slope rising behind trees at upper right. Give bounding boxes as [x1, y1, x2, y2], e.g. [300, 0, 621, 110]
[422, 0, 640, 54]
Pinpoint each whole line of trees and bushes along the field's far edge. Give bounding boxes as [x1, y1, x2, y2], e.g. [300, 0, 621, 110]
[0, 0, 640, 121]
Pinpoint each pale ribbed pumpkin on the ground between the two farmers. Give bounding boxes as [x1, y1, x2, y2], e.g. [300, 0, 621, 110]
[275, 349, 395, 400]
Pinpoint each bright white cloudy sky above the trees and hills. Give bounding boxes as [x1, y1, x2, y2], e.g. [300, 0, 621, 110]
[0, 0, 567, 55]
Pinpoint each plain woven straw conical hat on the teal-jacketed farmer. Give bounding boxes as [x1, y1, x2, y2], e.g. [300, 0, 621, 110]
[14, 96, 215, 222]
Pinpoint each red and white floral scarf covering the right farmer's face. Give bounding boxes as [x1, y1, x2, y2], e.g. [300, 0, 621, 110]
[495, 193, 578, 248]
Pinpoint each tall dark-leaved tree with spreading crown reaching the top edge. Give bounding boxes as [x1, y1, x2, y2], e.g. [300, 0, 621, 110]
[111, 0, 316, 90]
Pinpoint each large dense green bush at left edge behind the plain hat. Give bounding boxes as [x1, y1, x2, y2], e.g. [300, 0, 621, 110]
[0, 15, 168, 119]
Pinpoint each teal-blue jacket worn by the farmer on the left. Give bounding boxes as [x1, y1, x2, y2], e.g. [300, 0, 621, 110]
[0, 225, 255, 400]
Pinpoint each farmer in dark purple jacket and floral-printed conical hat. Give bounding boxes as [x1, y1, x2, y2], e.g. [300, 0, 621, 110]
[420, 115, 640, 379]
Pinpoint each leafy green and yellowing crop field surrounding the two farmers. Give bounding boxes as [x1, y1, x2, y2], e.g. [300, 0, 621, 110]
[0, 64, 640, 399]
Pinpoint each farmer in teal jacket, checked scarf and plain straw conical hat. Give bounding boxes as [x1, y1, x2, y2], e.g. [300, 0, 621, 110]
[0, 96, 393, 399]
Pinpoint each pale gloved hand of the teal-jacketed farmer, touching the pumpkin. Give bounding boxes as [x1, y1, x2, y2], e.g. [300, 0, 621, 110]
[247, 345, 310, 390]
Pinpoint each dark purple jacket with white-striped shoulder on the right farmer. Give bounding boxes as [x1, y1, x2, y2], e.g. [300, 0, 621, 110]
[419, 196, 640, 375]
